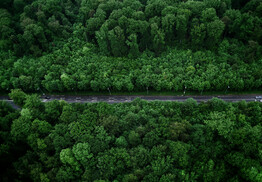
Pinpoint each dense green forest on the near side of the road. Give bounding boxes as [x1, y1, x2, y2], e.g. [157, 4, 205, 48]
[0, 90, 262, 182]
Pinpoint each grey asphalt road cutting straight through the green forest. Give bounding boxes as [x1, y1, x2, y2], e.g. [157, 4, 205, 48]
[0, 95, 262, 109]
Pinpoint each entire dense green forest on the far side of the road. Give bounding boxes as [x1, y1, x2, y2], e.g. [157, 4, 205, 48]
[0, 0, 262, 92]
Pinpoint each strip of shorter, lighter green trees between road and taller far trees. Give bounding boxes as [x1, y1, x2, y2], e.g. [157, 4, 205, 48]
[2, 39, 262, 92]
